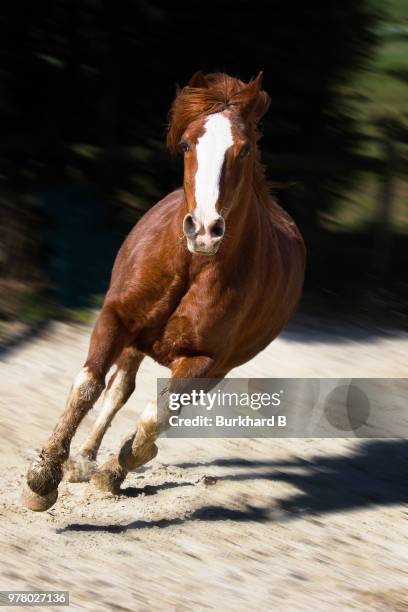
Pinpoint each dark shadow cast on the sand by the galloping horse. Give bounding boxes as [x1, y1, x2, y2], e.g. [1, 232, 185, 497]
[58, 440, 408, 533]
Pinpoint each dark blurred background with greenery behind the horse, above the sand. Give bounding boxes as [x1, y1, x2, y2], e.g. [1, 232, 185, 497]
[0, 0, 408, 341]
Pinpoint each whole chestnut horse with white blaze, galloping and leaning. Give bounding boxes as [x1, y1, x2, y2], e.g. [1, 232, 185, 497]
[23, 72, 305, 510]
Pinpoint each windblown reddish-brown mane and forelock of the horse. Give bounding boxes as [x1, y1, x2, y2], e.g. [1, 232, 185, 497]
[167, 72, 278, 213]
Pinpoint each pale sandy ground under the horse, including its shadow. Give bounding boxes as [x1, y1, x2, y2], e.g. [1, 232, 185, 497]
[0, 321, 408, 611]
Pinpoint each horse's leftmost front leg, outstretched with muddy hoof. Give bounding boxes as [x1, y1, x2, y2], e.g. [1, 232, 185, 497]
[22, 308, 128, 511]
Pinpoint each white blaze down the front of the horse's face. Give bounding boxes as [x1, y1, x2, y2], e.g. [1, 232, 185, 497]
[194, 113, 234, 227]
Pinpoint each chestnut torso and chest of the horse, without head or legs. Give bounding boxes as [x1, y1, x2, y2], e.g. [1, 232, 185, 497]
[105, 184, 304, 377]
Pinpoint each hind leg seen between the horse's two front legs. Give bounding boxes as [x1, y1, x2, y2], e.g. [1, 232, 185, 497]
[64, 346, 144, 482]
